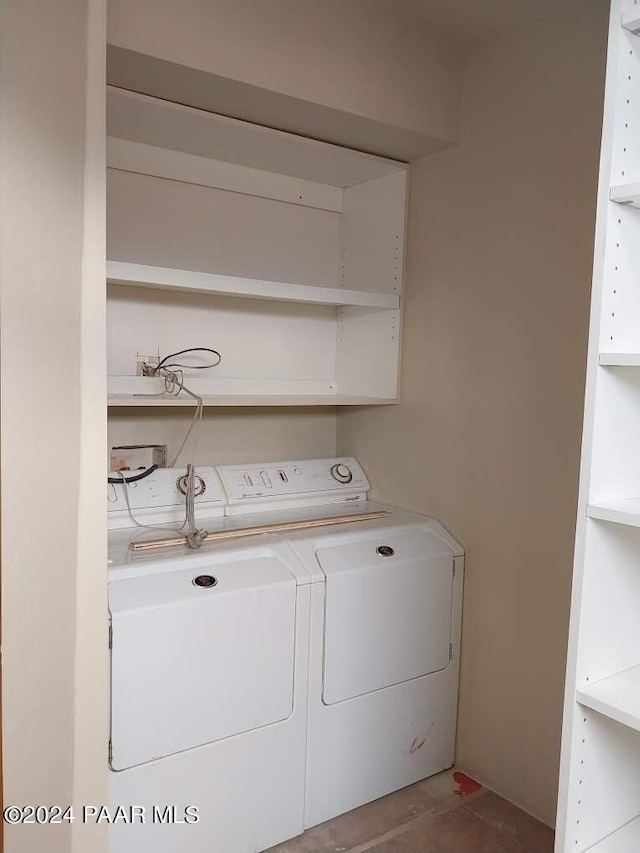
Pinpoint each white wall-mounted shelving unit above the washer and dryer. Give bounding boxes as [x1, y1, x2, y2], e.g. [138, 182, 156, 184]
[107, 87, 407, 406]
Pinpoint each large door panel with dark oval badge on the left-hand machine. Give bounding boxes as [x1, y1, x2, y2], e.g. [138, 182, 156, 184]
[109, 549, 296, 770]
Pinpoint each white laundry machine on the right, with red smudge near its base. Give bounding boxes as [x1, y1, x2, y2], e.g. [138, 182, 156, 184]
[218, 458, 464, 827]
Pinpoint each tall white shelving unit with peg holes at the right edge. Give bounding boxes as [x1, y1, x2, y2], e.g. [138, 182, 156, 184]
[556, 0, 640, 853]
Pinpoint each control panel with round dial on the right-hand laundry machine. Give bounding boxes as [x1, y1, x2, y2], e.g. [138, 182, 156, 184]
[217, 456, 369, 512]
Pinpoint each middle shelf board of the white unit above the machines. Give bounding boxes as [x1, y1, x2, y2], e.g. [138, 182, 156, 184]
[107, 261, 399, 309]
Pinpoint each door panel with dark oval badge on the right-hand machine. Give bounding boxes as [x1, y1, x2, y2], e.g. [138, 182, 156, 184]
[317, 525, 454, 705]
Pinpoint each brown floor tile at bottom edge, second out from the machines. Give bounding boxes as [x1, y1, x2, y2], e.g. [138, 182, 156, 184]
[370, 807, 523, 853]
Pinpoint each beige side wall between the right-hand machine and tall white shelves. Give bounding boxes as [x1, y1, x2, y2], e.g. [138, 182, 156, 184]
[338, 0, 607, 822]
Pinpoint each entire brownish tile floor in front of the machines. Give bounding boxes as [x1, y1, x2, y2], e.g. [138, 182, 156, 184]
[269, 770, 553, 853]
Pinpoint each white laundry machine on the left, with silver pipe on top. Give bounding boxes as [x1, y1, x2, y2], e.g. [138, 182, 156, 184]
[109, 468, 310, 853]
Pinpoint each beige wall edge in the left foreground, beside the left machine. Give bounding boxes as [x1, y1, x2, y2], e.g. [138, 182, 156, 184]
[0, 0, 108, 853]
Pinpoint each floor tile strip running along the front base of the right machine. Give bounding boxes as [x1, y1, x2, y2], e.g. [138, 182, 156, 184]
[269, 782, 441, 853]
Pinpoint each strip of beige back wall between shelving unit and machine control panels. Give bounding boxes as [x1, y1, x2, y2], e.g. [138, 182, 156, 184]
[109, 408, 336, 465]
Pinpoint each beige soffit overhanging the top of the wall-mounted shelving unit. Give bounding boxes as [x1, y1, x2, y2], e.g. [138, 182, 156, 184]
[109, 0, 463, 153]
